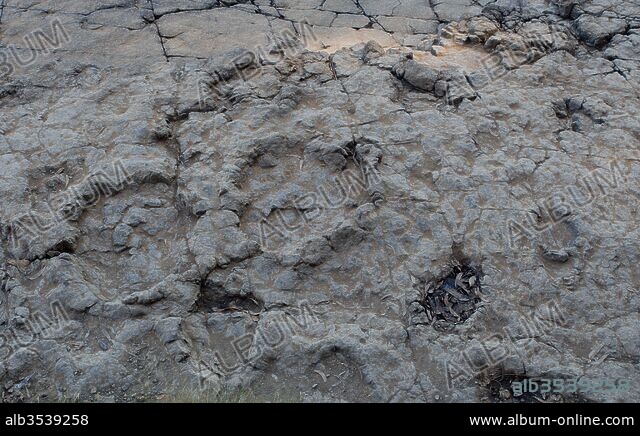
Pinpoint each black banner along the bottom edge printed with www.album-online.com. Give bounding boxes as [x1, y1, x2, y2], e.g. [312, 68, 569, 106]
[0, 403, 640, 435]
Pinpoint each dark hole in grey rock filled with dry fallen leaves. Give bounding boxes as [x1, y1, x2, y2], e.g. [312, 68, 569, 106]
[418, 261, 482, 331]
